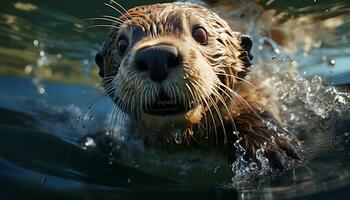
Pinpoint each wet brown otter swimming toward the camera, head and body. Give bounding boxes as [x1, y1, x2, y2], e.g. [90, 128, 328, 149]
[95, 2, 303, 170]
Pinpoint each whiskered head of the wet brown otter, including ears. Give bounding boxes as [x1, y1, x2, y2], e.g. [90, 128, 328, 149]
[96, 3, 251, 131]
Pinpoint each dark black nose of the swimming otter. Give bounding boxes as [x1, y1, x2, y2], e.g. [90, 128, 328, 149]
[135, 45, 179, 83]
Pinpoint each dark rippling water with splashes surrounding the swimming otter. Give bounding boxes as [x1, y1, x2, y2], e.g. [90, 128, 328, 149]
[0, 0, 350, 199]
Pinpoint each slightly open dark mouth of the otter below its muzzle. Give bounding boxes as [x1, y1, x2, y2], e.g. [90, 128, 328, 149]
[145, 95, 186, 115]
